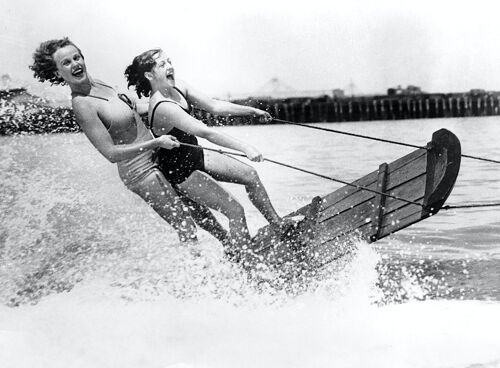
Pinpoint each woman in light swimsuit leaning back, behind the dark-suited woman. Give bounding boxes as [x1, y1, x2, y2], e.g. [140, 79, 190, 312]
[30, 37, 227, 241]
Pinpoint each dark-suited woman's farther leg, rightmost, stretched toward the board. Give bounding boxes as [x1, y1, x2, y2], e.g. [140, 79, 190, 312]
[205, 151, 283, 226]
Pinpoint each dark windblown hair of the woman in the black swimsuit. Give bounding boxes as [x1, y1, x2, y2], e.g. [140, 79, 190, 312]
[125, 49, 162, 98]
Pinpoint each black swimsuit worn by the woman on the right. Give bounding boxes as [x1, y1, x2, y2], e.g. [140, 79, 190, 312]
[149, 87, 205, 185]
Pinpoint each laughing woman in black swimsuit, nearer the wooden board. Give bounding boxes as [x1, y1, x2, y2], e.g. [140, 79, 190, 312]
[125, 49, 289, 250]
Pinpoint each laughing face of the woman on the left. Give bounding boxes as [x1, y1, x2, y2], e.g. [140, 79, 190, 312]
[52, 45, 88, 85]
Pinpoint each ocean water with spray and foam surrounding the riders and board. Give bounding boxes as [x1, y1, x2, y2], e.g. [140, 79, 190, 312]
[0, 117, 500, 368]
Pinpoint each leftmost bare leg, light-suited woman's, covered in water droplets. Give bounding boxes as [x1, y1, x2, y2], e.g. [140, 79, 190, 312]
[130, 170, 197, 241]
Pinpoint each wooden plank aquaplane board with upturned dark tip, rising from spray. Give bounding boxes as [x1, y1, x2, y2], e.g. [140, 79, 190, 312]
[254, 129, 461, 269]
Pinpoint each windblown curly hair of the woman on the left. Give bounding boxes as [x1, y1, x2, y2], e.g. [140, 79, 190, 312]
[29, 37, 84, 84]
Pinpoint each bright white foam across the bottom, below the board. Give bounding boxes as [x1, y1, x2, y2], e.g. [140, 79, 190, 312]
[0, 247, 500, 368]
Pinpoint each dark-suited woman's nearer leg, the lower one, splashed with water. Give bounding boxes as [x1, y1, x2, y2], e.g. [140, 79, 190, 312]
[177, 171, 250, 247]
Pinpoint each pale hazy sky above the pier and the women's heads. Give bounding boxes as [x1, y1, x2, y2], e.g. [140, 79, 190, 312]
[0, 0, 500, 97]
